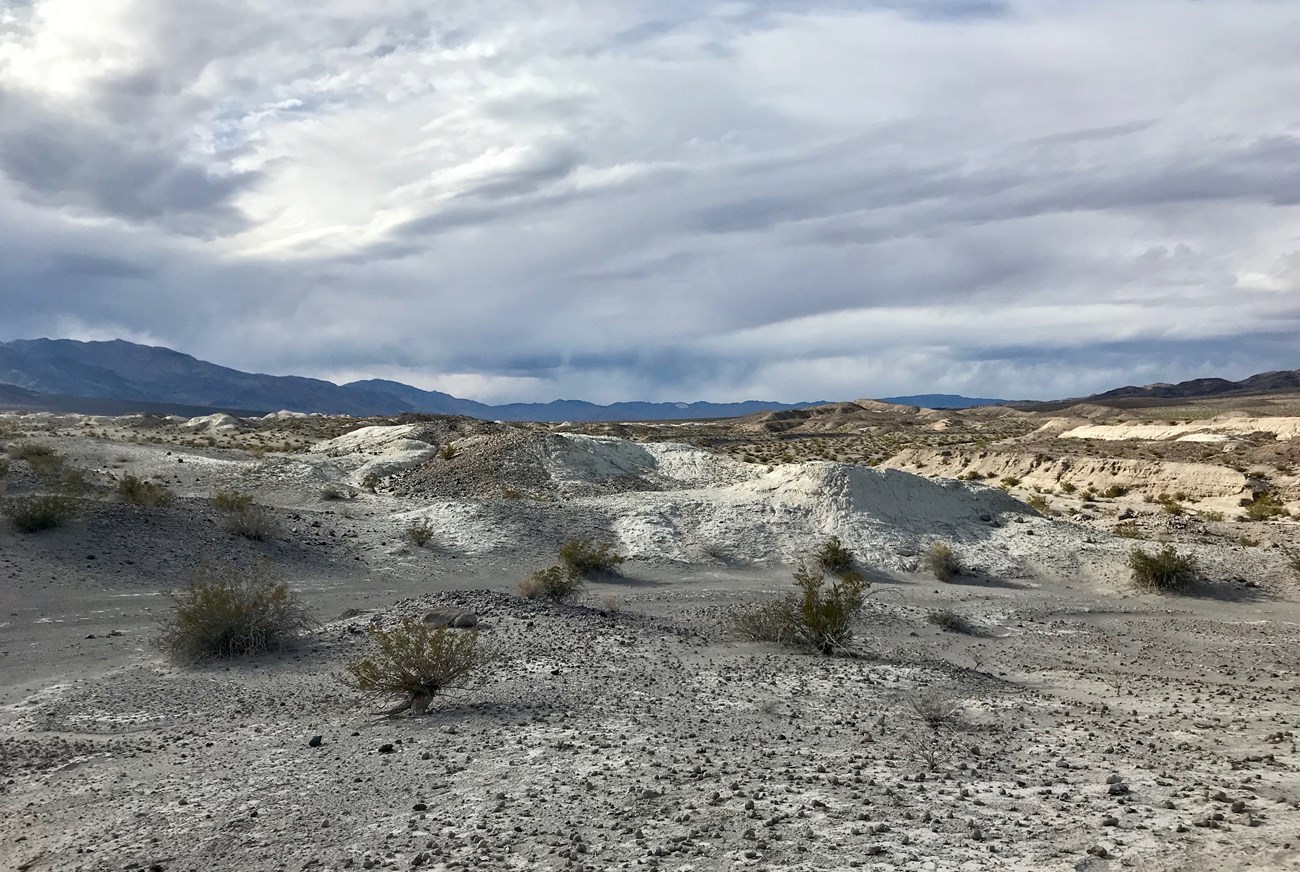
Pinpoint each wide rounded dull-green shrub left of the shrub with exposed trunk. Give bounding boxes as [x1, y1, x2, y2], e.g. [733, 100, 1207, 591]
[157, 564, 312, 663]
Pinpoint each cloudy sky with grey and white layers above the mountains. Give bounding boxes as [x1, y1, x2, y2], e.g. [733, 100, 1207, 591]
[0, 0, 1300, 403]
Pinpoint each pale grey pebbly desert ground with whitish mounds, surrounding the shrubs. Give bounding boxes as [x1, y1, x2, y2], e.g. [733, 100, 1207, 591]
[0, 418, 1300, 871]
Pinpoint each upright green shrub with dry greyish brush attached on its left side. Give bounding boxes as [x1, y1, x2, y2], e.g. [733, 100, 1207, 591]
[733, 563, 867, 654]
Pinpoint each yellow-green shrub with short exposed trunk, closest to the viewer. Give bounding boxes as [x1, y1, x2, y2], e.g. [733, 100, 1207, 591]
[345, 617, 478, 715]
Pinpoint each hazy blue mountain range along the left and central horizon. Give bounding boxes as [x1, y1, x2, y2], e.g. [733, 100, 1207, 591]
[0, 339, 997, 421]
